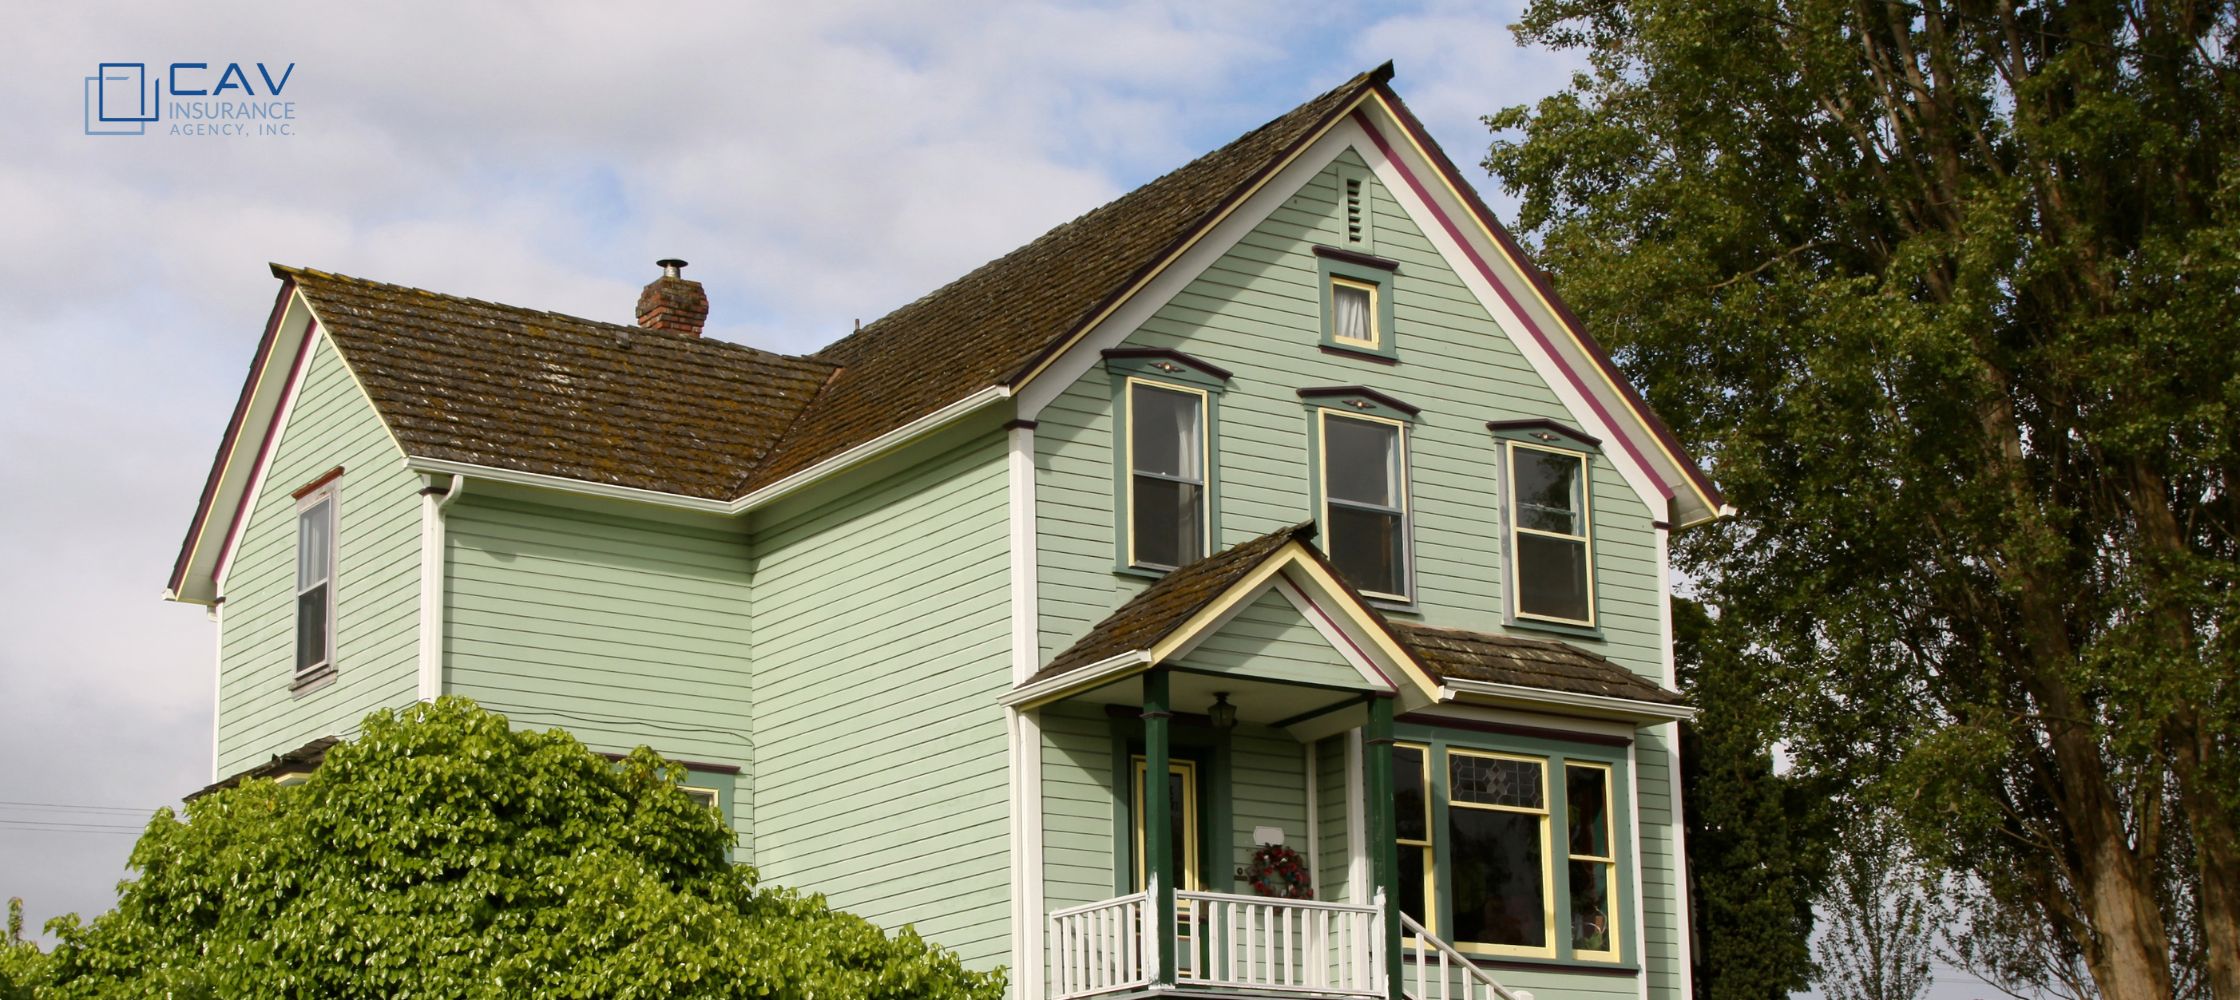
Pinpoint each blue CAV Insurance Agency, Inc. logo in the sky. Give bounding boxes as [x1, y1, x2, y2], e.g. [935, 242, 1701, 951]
[85, 63, 296, 137]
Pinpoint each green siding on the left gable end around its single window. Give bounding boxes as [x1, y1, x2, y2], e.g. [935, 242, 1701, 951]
[217, 339, 421, 776]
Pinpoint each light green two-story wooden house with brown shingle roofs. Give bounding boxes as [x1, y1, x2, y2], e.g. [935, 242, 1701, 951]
[168, 65, 1723, 1000]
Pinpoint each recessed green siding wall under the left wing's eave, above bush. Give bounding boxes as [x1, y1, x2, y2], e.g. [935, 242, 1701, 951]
[444, 487, 755, 861]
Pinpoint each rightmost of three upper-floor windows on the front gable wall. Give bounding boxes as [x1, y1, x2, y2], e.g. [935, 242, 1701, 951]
[1508, 442, 1595, 628]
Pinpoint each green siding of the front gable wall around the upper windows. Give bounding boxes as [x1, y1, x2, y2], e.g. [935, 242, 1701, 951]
[1035, 152, 1680, 998]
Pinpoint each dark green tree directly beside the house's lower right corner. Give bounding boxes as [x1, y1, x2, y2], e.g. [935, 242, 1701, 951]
[1673, 599, 1828, 1000]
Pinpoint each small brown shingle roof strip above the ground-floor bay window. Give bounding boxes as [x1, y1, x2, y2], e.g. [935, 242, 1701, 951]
[1393, 623, 1684, 704]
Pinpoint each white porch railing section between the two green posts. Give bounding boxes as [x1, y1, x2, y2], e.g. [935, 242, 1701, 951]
[1174, 892, 1384, 998]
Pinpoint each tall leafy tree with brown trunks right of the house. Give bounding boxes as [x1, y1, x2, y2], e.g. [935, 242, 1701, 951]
[1485, 0, 2240, 1000]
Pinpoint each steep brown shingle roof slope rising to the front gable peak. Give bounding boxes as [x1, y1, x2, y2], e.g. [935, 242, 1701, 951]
[739, 63, 1391, 493]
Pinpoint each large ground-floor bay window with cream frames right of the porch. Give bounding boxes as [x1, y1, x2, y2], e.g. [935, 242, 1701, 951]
[1393, 740, 1628, 962]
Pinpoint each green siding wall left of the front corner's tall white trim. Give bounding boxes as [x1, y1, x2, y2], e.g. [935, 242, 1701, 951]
[753, 433, 1010, 966]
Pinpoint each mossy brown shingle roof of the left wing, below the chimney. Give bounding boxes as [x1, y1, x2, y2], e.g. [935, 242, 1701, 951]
[273, 265, 833, 500]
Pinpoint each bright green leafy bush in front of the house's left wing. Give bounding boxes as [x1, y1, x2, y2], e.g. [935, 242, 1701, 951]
[24, 697, 1004, 1000]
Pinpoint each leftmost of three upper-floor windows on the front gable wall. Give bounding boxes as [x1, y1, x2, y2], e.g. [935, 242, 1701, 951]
[1127, 379, 1210, 570]
